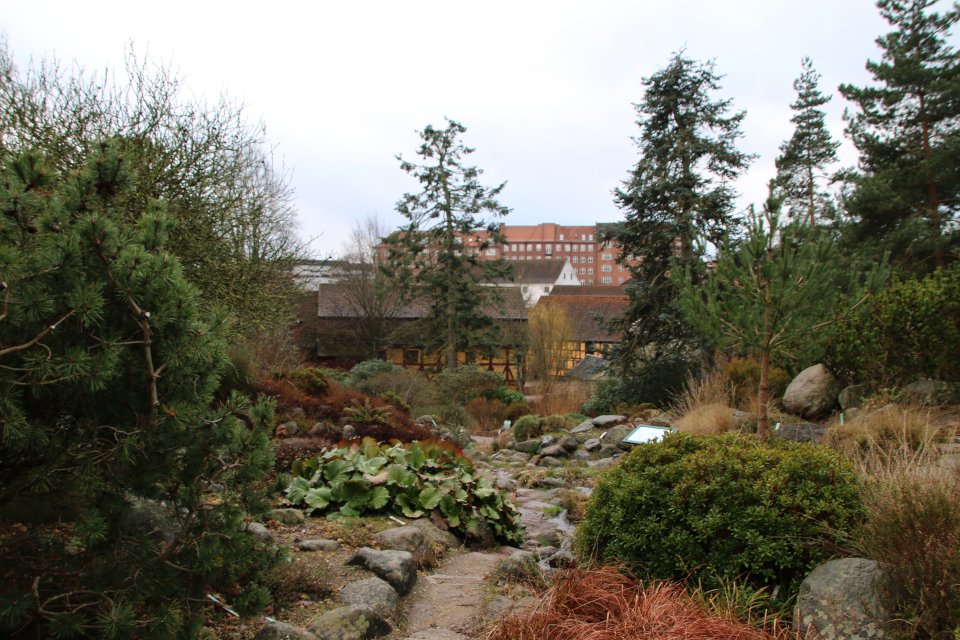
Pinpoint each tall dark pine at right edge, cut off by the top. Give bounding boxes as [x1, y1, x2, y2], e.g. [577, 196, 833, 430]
[840, 0, 960, 267]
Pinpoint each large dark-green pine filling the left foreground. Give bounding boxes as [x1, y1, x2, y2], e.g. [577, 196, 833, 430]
[0, 147, 282, 638]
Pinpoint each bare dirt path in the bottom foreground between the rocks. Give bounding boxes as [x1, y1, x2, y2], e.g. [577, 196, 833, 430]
[395, 551, 507, 640]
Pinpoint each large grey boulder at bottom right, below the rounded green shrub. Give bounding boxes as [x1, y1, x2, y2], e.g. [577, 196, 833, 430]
[794, 558, 887, 640]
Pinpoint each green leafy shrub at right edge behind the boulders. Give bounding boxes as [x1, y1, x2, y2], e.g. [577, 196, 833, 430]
[830, 264, 960, 388]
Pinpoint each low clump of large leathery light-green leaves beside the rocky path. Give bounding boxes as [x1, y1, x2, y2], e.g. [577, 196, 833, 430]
[287, 438, 523, 544]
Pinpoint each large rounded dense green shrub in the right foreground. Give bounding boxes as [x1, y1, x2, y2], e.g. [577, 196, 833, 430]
[577, 433, 865, 599]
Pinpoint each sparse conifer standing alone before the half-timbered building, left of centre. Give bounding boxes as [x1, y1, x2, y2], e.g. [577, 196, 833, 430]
[384, 119, 510, 371]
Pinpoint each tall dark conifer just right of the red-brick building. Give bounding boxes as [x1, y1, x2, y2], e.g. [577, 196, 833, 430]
[601, 51, 752, 390]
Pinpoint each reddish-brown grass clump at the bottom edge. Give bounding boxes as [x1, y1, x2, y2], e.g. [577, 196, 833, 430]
[486, 566, 782, 640]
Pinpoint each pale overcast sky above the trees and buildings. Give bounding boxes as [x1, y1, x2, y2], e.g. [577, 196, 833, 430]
[0, 0, 944, 257]
